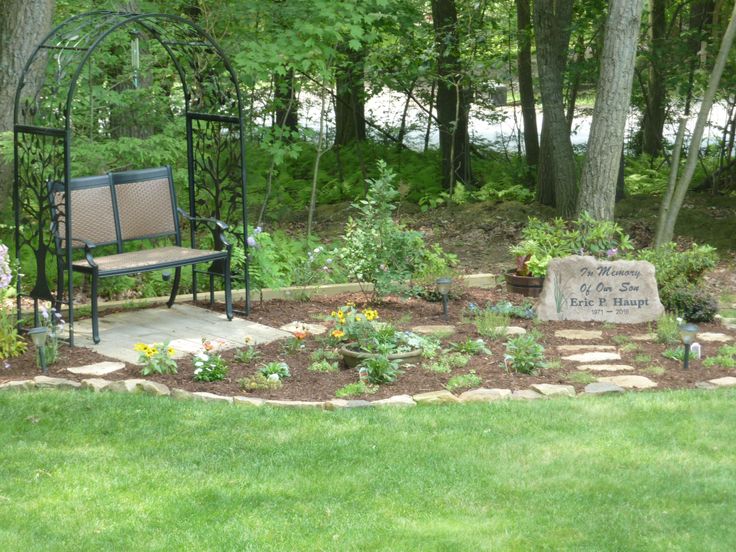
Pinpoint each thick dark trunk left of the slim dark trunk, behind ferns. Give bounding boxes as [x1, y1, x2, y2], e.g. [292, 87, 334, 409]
[432, 0, 473, 191]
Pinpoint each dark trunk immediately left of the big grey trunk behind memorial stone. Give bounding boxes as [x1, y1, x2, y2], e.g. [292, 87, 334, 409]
[534, 0, 577, 217]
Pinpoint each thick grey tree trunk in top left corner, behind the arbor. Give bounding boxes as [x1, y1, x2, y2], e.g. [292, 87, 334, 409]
[0, 0, 56, 213]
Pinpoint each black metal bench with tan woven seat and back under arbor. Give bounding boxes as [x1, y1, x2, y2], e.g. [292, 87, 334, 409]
[49, 167, 233, 343]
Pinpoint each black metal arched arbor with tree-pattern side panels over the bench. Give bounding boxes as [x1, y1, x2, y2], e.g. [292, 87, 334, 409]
[13, 11, 250, 345]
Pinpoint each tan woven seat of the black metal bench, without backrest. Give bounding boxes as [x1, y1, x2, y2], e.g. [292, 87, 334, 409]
[72, 245, 227, 276]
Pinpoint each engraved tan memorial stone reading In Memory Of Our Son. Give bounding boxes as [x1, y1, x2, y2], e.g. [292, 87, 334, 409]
[537, 255, 664, 324]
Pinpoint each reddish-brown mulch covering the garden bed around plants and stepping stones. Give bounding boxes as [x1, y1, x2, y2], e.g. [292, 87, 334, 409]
[0, 288, 736, 400]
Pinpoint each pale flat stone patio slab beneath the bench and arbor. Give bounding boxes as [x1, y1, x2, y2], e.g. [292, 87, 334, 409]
[74, 305, 291, 364]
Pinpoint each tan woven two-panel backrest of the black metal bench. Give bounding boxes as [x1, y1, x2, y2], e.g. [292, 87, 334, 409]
[50, 167, 181, 251]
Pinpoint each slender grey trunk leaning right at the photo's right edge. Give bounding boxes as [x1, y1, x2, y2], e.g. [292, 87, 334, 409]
[655, 0, 736, 245]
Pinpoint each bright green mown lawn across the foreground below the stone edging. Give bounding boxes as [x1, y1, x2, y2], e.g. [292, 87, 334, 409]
[0, 390, 736, 552]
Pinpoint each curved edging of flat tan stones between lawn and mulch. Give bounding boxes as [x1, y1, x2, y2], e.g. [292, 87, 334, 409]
[0, 376, 736, 411]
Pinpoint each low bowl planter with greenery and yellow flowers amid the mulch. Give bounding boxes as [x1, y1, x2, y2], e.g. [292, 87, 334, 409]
[330, 303, 425, 368]
